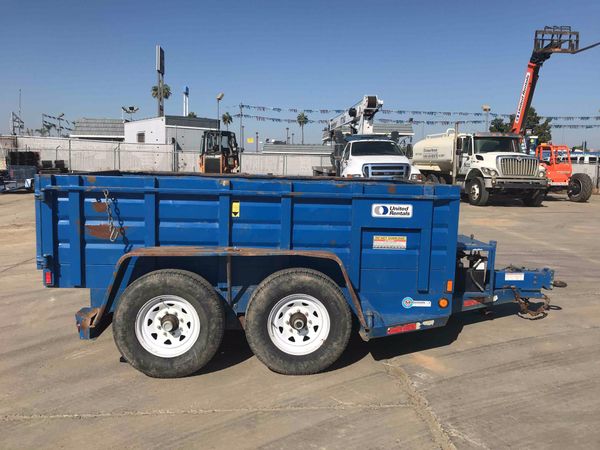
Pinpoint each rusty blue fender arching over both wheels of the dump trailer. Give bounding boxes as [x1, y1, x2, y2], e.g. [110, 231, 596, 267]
[75, 246, 369, 339]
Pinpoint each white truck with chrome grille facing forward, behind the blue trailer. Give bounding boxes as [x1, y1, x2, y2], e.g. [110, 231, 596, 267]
[339, 135, 423, 181]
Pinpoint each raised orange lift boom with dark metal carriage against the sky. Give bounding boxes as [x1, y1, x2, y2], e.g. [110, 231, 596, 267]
[511, 26, 600, 134]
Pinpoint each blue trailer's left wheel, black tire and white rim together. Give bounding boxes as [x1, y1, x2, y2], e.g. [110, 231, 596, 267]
[113, 269, 225, 378]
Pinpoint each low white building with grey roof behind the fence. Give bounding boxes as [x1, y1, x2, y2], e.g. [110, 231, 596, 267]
[125, 116, 218, 152]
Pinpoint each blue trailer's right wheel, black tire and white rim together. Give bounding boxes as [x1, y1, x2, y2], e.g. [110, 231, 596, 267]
[245, 268, 352, 375]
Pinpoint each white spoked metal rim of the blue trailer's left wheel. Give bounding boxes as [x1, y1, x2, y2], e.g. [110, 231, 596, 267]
[135, 295, 200, 358]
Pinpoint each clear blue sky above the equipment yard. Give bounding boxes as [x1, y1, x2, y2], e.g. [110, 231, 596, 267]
[0, 0, 600, 149]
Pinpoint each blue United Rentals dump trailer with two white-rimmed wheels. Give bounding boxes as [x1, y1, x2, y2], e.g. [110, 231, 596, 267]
[35, 172, 554, 377]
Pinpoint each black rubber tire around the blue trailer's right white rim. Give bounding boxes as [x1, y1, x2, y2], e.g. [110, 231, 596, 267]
[245, 268, 352, 375]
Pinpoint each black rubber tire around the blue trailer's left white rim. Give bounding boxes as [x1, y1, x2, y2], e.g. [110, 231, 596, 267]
[113, 269, 225, 378]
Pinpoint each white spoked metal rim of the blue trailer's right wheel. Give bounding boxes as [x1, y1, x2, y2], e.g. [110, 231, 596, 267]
[267, 294, 331, 356]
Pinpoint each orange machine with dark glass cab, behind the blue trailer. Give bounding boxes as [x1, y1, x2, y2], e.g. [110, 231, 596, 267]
[199, 130, 240, 174]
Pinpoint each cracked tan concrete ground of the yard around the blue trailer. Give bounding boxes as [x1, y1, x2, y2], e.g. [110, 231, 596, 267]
[0, 194, 600, 449]
